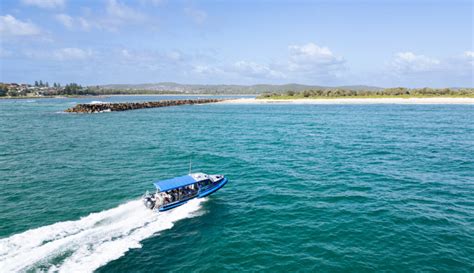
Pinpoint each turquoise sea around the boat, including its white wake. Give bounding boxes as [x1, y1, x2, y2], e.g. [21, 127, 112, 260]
[0, 97, 474, 272]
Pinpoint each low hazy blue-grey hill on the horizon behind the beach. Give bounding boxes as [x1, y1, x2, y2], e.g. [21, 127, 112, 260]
[95, 82, 383, 94]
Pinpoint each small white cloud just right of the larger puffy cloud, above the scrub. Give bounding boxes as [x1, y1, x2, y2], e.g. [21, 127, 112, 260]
[392, 51, 440, 73]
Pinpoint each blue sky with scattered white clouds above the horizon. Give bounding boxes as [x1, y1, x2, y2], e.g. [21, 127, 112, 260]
[0, 0, 474, 87]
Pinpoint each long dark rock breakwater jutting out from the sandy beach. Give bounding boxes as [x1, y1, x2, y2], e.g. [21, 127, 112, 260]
[65, 99, 224, 113]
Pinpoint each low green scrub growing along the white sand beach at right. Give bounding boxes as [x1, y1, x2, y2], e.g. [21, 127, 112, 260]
[257, 87, 474, 99]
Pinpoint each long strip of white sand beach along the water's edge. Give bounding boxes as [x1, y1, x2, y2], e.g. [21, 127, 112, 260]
[220, 98, 474, 104]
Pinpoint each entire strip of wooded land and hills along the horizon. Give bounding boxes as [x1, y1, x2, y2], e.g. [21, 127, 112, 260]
[0, 80, 474, 99]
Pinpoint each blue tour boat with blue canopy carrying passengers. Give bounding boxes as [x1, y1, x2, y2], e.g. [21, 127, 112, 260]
[143, 173, 228, 211]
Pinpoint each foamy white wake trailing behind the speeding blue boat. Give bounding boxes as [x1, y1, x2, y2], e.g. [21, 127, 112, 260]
[0, 199, 205, 272]
